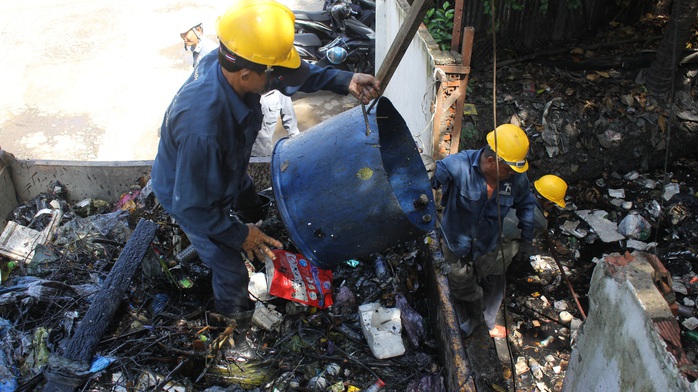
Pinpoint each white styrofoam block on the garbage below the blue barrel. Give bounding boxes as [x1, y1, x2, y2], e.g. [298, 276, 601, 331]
[359, 302, 405, 359]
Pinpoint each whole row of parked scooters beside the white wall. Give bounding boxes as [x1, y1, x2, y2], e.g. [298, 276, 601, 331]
[293, 0, 375, 73]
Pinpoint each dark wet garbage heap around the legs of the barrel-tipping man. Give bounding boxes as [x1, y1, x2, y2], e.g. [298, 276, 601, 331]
[0, 179, 445, 391]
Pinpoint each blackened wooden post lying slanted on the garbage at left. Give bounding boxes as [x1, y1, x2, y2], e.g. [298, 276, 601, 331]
[43, 219, 159, 392]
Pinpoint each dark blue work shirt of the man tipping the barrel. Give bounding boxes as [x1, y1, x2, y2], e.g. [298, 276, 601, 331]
[151, 54, 353, 248]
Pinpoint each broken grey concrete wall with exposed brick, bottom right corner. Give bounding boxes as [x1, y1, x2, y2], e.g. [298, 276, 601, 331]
[563, 252, 698, 392]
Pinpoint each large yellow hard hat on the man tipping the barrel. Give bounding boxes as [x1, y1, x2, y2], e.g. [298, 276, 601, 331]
[216, 0, 301, 68]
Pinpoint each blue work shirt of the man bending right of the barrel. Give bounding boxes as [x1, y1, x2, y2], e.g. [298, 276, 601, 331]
[432, 148, 536, 260]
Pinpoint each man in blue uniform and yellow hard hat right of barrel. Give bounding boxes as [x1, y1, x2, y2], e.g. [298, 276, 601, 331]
[432, 124, 535, 336]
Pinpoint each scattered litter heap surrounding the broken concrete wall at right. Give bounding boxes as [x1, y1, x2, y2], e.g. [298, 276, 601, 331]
[497, 156, 698, 391]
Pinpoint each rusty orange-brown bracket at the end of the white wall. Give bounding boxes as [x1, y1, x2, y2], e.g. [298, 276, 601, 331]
[431, 27, 474, 160]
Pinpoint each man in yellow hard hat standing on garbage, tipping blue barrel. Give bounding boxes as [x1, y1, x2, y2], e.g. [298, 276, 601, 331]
[151, 0, 380, 359]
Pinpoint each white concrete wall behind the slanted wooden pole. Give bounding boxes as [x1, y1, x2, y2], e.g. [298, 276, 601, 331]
[376, 0, 455, 152]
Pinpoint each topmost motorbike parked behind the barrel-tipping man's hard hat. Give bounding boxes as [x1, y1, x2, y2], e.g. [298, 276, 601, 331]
[293, 0, 375, 44]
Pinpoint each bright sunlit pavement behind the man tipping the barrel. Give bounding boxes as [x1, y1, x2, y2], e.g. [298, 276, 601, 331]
[0, 0, 355, 161]
